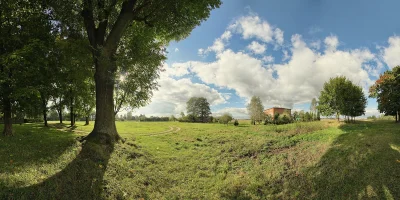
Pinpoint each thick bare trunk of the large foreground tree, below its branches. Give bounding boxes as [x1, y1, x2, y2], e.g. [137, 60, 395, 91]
[86, 55, 120, 144]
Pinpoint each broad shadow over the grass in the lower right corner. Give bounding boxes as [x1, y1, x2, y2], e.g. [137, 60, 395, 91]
[289, 119, 400, 199]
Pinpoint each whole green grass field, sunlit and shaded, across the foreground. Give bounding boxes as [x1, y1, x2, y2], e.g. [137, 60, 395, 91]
[0, 121, 400, 199]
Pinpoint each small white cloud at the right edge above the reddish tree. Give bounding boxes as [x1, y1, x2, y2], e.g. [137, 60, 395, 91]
[381, 36, 400, 69]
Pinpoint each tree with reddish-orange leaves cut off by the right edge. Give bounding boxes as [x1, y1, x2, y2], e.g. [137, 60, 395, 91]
[369, 66, 400, 122]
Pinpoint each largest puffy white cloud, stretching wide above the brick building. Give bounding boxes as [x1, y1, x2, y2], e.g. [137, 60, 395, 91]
[184, 34, 377, 107]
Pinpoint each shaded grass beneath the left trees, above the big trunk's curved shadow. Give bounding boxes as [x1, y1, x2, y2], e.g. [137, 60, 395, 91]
[0, 124, 76, 170]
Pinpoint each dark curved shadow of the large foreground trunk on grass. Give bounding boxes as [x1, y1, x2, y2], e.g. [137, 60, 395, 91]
[0, 124, 114, 199]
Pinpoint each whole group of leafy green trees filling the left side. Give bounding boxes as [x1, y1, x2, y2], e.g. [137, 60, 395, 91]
[0, 0, 221, 141]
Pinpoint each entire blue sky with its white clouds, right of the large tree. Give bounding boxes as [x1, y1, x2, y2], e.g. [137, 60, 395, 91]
[133, 0, 400, 118]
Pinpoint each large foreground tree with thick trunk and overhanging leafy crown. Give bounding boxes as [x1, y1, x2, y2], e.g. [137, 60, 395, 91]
[50, 0, 221, 144]
